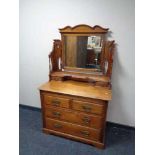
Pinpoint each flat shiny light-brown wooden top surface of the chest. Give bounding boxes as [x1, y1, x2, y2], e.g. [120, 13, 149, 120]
[39, 80, 112, 101]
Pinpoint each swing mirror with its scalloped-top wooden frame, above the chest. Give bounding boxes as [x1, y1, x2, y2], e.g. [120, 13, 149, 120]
[59, 24, 108, 74]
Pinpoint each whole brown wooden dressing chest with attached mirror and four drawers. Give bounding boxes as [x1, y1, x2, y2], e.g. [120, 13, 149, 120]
[39, 24, 114, 148]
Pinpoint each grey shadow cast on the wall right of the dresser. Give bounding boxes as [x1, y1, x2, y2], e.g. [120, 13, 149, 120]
[107, 41, 134, 125]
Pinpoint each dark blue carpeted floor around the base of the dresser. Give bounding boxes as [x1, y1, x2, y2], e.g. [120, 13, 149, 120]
[19, 107, 135, 155]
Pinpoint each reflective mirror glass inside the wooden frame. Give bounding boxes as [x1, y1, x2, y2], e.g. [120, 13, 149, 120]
[64, 35, 102, 71]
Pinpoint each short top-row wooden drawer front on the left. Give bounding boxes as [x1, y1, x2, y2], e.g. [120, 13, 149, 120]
[44, 95, 70, 108]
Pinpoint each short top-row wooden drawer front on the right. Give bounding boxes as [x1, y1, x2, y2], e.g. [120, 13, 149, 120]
[72, 100, 106, 115]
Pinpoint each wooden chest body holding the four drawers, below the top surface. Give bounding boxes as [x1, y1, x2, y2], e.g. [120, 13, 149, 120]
[40, 88, 108, 148]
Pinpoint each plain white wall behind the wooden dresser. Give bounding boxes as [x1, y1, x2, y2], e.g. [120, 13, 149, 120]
[19, 0, 135, 126]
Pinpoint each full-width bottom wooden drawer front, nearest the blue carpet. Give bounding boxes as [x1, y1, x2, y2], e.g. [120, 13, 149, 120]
[46, 118, 101, 141]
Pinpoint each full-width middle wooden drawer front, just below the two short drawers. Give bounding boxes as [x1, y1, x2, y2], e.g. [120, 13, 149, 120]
[45, 108, 103, 129]
